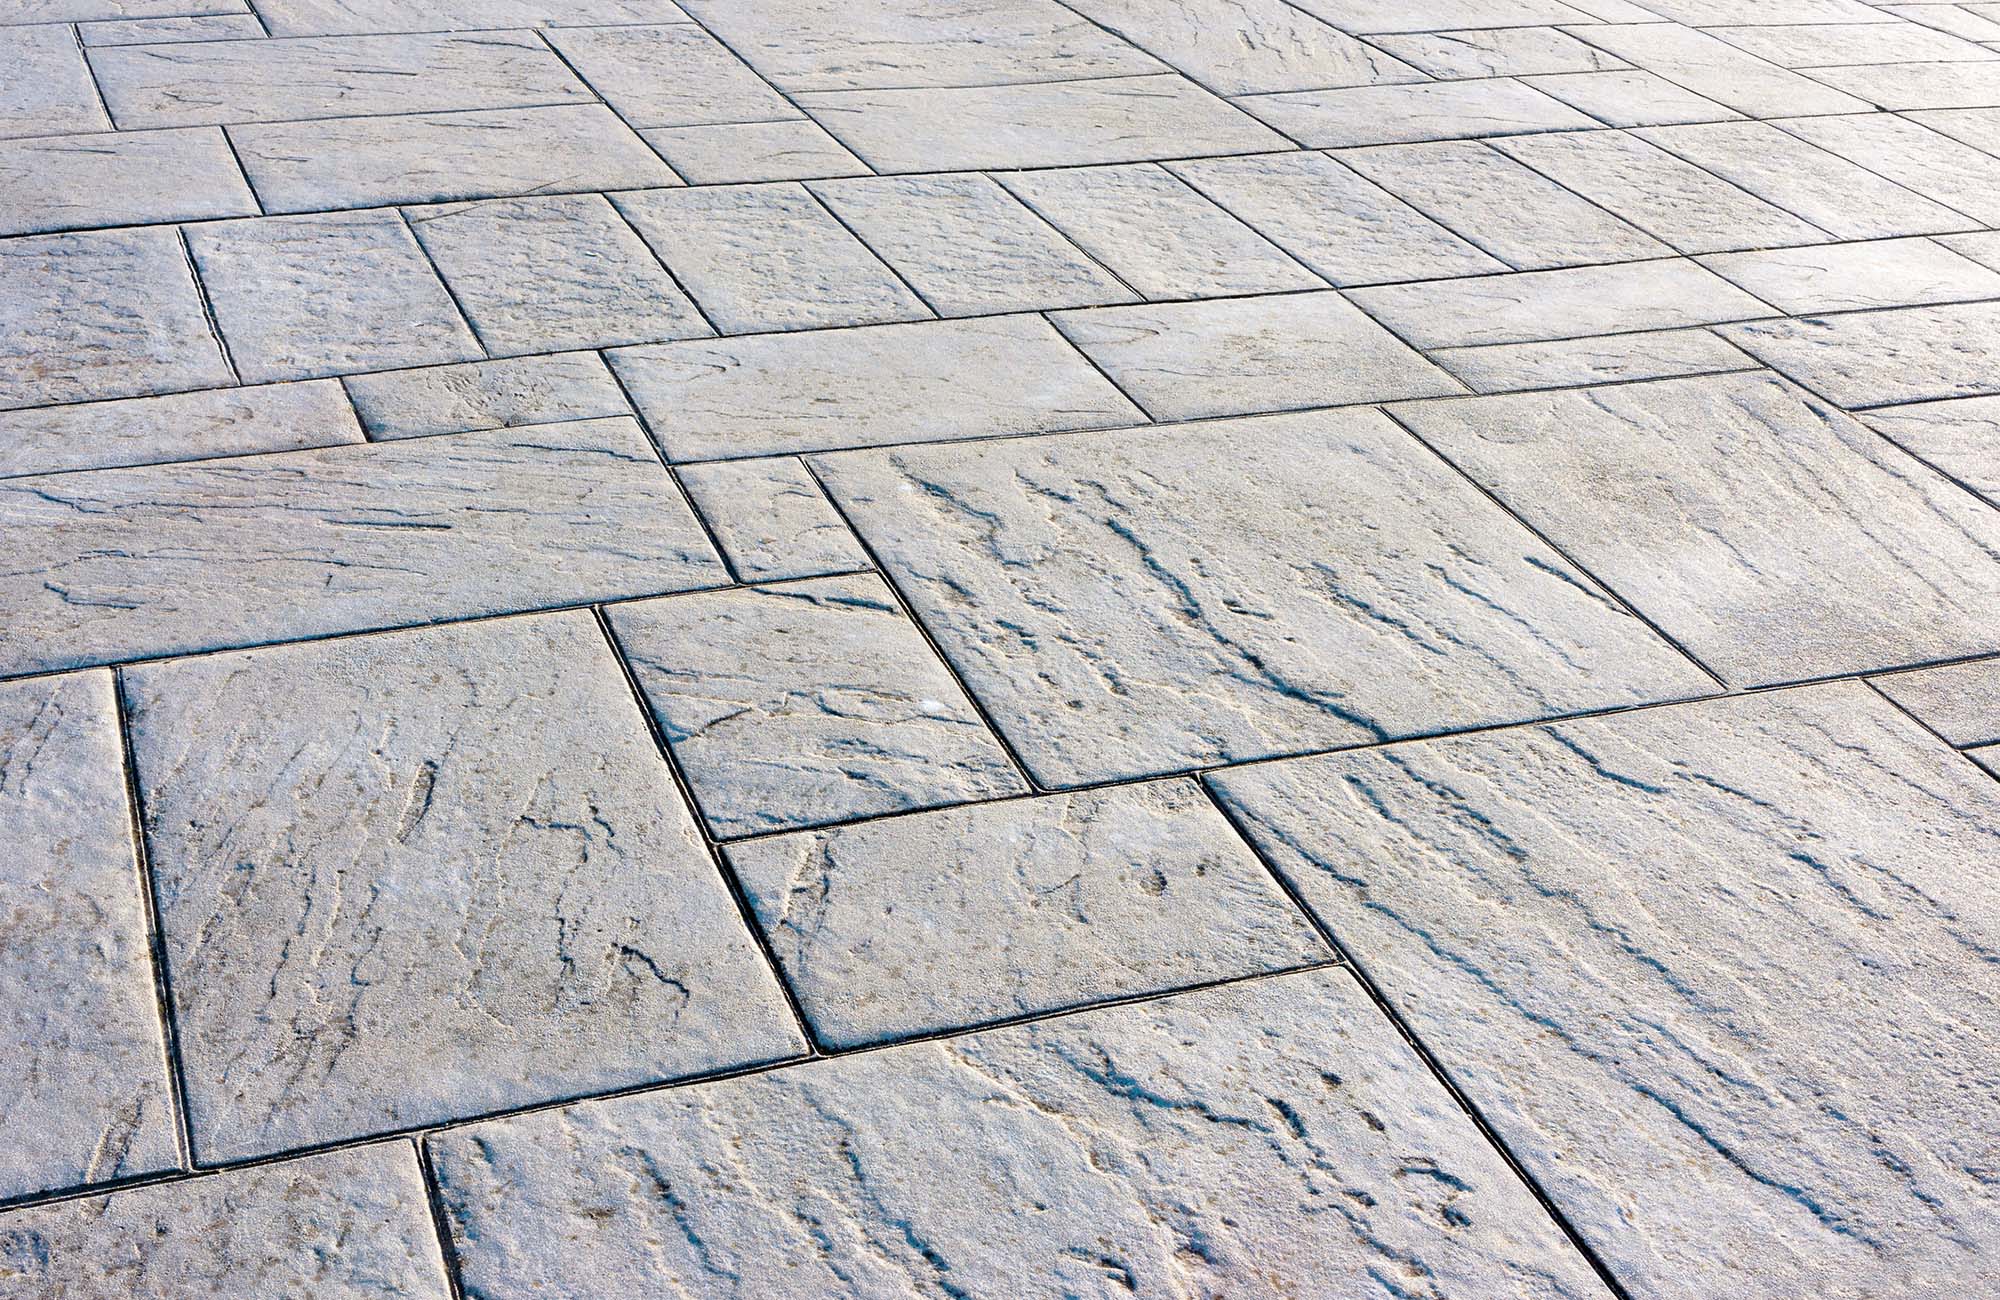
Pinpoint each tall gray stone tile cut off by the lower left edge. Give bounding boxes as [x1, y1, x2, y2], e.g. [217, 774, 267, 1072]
[0, 672, 180, 1208]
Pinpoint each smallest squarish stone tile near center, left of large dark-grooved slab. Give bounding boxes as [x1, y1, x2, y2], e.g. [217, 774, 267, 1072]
[680, 456, 868, 582]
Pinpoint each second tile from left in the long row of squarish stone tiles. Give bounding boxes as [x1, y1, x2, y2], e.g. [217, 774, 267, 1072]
[188, 210, 484, 382]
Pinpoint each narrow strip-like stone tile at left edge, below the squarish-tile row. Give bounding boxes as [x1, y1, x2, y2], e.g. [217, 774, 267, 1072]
[0, 380, 362, 476]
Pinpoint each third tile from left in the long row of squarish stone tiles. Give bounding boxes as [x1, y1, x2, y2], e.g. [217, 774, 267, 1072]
[408, 194, 712, 356]
